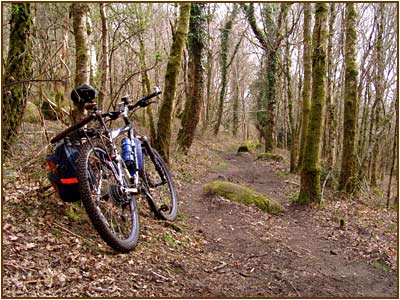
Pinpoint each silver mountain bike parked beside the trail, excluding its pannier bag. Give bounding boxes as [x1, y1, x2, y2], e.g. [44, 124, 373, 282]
[50, 88, 178, 253]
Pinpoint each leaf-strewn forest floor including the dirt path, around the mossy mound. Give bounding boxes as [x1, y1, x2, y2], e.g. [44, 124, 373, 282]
[2, 122, 399, 298]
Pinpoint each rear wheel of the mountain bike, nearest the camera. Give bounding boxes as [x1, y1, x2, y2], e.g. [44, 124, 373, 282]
[76, 142, 139, 253]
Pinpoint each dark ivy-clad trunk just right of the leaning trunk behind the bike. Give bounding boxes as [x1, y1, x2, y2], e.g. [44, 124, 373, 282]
[177, 3, 207, 153]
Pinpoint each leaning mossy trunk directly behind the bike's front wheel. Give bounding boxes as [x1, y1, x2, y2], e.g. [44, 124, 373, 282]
[154, 3, 191, 163]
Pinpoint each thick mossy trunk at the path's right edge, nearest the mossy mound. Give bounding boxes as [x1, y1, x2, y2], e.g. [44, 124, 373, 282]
[298, 2, 328, 203]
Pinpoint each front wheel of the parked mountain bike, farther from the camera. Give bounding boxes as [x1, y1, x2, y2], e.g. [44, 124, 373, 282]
[141, 148, 178, 221]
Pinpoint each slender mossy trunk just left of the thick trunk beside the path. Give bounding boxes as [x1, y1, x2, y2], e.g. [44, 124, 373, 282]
[297, 3, 312, 170]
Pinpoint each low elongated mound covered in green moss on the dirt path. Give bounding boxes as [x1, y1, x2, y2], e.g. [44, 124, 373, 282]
[203, 181, 284, 213]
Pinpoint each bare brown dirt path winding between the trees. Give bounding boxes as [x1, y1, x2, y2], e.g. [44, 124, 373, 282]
[179, 153, 397, 297]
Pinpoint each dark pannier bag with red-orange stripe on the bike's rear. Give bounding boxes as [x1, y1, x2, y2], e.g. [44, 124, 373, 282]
[46, 140, 80, 202]
